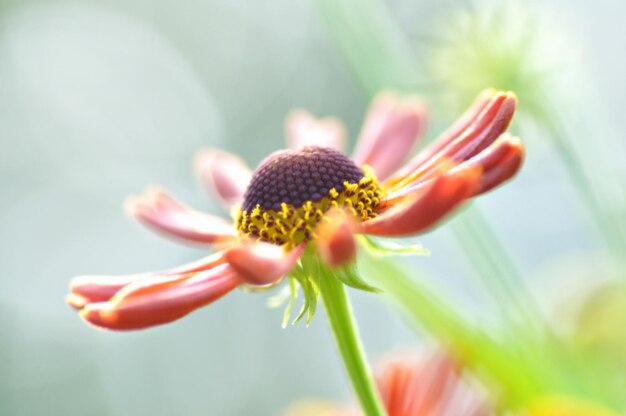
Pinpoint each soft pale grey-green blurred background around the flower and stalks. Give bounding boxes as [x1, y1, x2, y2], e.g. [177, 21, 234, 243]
[0, 0, 626, 416]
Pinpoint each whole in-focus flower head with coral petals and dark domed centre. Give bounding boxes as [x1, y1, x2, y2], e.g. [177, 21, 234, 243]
[67, 90, 523, 330]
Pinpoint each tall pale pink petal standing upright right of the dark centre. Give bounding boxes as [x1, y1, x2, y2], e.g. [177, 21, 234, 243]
[354, 92, 428, 180]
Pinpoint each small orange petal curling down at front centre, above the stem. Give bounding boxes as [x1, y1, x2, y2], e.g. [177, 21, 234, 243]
[316, 211, 357, 267]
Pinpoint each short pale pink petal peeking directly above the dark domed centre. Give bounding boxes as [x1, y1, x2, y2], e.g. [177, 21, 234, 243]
[285, 109, 346, 152]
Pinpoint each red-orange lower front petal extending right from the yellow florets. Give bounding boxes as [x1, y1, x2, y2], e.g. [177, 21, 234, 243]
[361, 168, 480, 236]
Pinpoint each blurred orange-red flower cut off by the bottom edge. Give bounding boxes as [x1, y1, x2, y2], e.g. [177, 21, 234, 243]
[285, 351, 495, 416]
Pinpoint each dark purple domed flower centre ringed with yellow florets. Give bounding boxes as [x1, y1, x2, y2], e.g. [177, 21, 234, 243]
[236, 146, 382, 247]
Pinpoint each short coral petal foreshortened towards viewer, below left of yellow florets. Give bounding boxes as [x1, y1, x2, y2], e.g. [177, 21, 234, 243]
[225, 242, 304, 285]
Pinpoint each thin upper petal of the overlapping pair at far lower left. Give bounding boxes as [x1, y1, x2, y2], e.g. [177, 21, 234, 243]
[66, 252, 224, 309]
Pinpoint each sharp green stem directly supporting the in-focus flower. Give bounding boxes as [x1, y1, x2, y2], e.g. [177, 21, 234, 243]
[320, 266, 387, 416]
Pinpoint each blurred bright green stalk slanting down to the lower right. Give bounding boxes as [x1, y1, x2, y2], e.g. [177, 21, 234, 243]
[359, 247, 626, 409]
